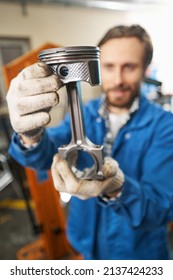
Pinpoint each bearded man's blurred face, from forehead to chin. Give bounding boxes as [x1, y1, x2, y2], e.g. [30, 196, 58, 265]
[100, 37, 144, 108]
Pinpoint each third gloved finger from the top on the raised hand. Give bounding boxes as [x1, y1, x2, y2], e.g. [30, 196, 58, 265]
[16, 92, 59, 116]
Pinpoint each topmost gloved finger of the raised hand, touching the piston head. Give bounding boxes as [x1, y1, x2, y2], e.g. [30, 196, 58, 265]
[18, 62, 52, 80]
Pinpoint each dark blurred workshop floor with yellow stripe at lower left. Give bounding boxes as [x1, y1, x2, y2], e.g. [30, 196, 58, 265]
[0, 174, 173, 260]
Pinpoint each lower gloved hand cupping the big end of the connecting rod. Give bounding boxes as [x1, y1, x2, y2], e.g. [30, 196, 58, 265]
[51, 154, 124, 199]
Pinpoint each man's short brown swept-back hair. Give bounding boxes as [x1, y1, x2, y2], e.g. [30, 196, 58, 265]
[98, 24, 153, 69]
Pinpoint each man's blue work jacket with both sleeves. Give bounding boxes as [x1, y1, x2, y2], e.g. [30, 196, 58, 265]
[9, 97, 173, 260]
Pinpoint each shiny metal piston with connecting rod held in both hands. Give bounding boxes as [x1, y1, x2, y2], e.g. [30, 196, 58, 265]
[38, 46, 103, 179]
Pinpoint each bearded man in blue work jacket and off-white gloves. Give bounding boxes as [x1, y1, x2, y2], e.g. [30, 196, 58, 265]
[7, 25, 173, 259]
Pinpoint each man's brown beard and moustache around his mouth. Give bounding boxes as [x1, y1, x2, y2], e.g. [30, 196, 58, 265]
[104, 85, 140, 109]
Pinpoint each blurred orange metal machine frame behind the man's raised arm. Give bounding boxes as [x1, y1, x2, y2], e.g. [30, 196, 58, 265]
[3, 43, 82, 260]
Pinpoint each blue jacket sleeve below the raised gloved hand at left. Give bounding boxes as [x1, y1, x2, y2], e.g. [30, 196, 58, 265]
[8, 116, 71, 171]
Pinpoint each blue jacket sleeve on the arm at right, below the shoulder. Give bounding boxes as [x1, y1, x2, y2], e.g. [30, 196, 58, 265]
[99, 112, 173, 229]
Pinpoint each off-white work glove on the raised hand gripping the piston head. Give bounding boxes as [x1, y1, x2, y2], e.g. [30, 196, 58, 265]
[7, 62, 61, 139]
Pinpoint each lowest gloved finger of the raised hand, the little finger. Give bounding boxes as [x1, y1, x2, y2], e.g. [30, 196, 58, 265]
[11, 112, 50, 133]
